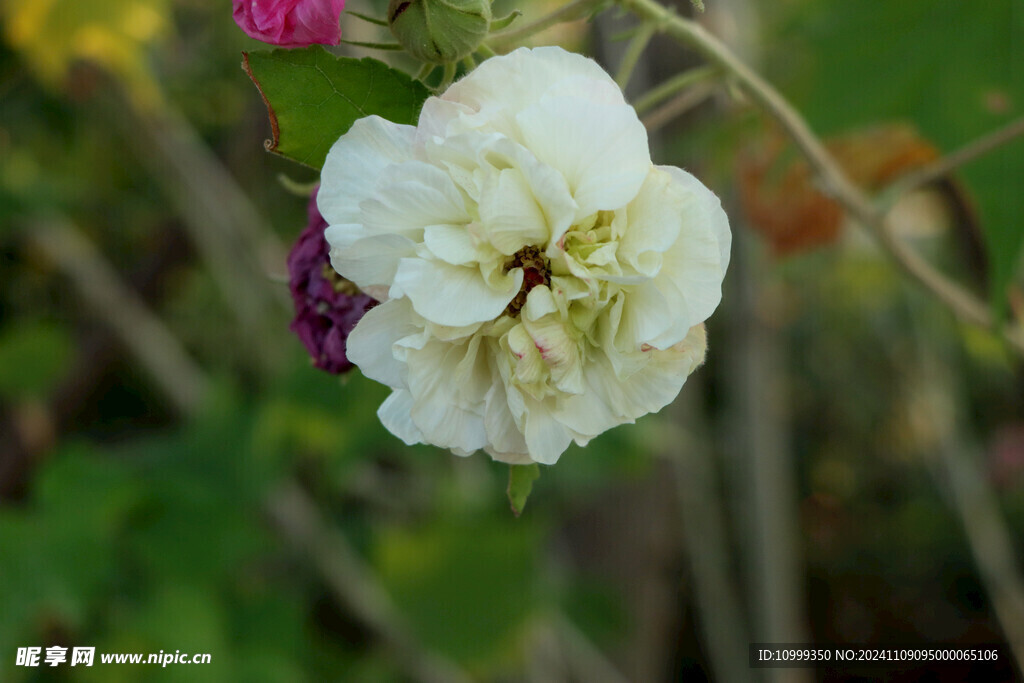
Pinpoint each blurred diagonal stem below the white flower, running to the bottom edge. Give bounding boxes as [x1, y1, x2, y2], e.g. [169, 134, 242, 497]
[266, 482, 472, 683]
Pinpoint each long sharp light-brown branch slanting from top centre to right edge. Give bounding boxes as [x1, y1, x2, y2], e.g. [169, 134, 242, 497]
[618, 0, 1024, 354]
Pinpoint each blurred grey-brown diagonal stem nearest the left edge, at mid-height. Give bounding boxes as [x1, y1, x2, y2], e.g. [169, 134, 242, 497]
[28, 218, 210, 415]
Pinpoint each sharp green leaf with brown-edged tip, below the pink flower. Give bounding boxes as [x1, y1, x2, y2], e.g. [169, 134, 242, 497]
[242, 45, 430, 169]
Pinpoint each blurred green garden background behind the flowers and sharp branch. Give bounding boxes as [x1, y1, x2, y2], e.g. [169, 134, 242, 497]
[0, 0, 1024, 682]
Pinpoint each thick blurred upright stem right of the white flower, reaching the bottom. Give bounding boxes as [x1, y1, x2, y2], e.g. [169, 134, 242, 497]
[721, 235, 811, 683]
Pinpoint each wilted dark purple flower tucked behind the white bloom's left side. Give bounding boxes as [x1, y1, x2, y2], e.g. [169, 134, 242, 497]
[288, 188, 377, 375]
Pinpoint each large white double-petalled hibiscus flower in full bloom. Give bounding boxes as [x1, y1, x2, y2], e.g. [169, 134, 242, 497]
[318, 47, 731, 464]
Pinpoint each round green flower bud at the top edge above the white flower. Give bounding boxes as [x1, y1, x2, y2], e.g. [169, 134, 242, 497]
[387, 0, 490, 65]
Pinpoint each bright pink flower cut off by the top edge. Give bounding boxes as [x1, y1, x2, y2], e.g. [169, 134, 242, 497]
[232, 0, 345, 47]
